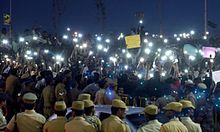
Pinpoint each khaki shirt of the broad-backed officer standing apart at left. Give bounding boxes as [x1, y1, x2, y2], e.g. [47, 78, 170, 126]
[7, 110, 46, 132]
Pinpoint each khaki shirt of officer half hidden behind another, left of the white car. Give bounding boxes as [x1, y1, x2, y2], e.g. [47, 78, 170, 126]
[85, 116, 102, 132]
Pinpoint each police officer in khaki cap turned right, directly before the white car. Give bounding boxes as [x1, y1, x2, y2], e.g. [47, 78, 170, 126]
[101, 99, 131, 132]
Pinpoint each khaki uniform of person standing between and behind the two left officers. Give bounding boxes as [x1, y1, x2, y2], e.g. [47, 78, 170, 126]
[42, 86, 55, 118]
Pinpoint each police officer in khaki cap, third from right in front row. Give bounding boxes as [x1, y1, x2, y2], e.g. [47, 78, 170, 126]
[137, 105, 162, 132]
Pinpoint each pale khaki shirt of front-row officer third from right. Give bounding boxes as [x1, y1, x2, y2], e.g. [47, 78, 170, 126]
[137, 119, 162, 132]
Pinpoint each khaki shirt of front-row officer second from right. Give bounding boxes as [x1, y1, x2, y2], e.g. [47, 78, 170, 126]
[160, 118, 188, 132]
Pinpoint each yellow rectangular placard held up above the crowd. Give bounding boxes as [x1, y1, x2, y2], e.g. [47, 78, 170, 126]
[125, 35, 141, 49]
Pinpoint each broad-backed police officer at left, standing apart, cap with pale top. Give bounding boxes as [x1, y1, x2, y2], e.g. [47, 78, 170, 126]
[6, 92, 46, 132]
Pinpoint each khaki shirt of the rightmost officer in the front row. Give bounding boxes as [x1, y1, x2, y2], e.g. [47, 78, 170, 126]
[180, 117, 202, 132]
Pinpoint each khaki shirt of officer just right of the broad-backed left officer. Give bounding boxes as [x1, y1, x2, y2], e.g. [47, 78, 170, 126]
[44, 117, 67, 132]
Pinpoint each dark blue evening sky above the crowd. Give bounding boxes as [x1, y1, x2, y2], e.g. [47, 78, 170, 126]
[0, 0, 220, 34]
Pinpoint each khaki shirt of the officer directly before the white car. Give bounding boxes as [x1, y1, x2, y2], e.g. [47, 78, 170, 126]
[101, 115, 131, 132]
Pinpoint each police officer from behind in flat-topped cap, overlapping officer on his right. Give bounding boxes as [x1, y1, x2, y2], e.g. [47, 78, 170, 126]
[64, 101, 96, 132]
